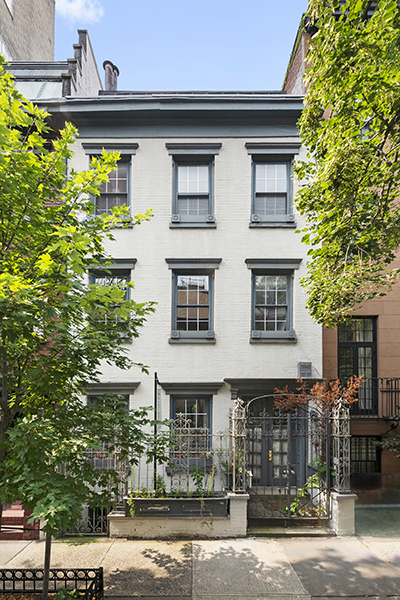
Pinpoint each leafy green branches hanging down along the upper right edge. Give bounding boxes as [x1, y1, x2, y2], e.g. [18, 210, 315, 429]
[296, 0, 400, 326]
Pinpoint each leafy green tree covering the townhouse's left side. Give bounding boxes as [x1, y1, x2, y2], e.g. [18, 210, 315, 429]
[0, 54, 158, 588]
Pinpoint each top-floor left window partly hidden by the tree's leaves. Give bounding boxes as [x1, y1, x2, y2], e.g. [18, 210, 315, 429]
[82, 142, 138, 220]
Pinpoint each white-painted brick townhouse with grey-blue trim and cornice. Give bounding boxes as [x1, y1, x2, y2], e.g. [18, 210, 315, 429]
[42, 91, 322, 484]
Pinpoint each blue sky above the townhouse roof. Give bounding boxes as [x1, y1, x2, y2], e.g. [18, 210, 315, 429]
[55, 0, 308, 91]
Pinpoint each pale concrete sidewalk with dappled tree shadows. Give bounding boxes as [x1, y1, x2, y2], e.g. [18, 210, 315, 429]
[0, 537, 400, 600]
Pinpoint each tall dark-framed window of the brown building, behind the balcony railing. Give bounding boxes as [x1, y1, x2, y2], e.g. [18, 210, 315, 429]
[338, 317, 378, 414]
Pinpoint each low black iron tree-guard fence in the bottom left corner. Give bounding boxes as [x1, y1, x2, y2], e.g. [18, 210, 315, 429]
[0, 567, 104, 600]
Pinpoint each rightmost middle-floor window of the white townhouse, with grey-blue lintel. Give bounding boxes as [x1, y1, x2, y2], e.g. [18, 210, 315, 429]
[246, 259, 301, 343]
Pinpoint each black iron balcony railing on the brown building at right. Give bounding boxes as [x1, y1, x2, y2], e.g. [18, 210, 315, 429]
[350, 377, 400, 419]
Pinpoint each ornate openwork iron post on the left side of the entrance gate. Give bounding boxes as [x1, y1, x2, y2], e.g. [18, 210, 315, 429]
[232, 398, 246, 493]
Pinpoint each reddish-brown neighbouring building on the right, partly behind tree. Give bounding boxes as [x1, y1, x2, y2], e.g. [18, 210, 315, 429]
[283, 7, 400, 504]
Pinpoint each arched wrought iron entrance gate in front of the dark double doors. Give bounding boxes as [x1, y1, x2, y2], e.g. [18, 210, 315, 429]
[232, 396, 350, 521]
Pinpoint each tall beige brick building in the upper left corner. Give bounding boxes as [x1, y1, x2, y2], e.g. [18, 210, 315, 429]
[0, 0, 55, 61]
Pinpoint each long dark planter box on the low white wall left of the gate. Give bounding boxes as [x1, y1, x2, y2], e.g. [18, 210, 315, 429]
[125, 497, 229, 518]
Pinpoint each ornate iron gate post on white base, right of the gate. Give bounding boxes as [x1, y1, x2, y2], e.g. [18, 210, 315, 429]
[331, 401, 357, 535]
